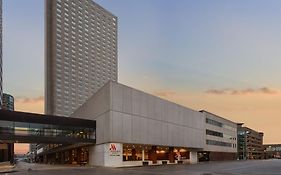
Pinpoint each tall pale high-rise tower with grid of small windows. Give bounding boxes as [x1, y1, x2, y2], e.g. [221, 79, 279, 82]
[45, 0, 118, 116]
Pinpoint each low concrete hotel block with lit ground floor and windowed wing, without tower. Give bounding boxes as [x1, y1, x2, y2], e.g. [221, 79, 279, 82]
[71, 81, 237, 167]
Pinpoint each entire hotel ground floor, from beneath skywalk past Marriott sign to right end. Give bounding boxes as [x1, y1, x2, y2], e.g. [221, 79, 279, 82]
[36, 143, 198, 167]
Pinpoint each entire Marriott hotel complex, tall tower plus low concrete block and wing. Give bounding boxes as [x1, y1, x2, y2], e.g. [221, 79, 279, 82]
[41, 0, 237, 167]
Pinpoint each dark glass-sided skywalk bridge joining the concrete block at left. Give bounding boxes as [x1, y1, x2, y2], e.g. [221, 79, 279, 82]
[0, 110, 96, 144]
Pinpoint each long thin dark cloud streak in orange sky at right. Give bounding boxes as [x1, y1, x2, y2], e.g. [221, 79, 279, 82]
[206, 87, 279, 95]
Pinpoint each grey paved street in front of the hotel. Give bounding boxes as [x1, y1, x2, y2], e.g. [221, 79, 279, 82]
[4, 159, 281, 175]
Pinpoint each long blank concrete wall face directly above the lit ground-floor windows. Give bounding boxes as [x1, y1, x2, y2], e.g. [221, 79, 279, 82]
[110, 82, 205, 148]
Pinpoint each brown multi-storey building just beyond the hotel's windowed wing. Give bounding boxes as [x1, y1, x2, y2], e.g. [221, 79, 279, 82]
[237, 123, 264, 160]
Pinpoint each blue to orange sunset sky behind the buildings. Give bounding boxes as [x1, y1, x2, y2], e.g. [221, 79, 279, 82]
[3, 0, 281, 153]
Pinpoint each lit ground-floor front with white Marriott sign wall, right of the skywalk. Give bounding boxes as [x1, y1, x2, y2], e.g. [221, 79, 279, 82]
[89, 143, 198, 167]
